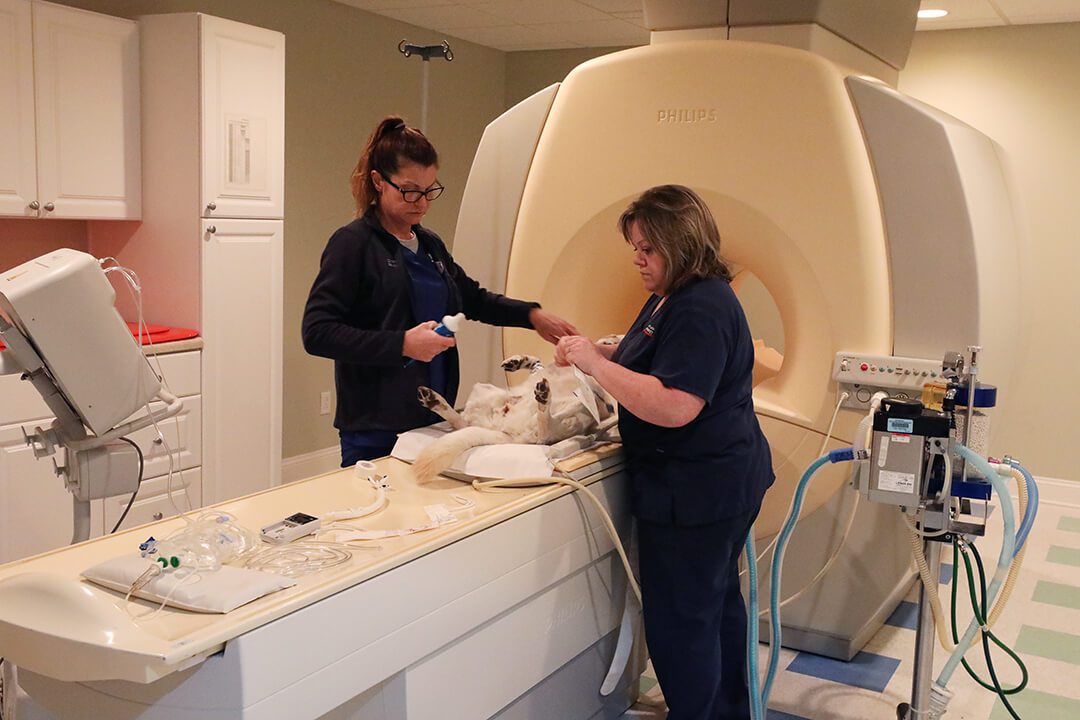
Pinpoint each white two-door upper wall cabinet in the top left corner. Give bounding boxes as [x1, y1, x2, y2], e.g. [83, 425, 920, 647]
[0, 0, 141, 219]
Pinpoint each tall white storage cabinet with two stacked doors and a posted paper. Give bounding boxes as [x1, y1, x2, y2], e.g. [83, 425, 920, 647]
[116, 13, 285, 503]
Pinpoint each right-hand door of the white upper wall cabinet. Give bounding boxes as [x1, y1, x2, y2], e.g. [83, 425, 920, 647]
[33, 2, 141, 219]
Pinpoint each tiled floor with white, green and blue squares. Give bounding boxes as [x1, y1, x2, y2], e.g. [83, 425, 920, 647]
[624, 481, 1080, 720]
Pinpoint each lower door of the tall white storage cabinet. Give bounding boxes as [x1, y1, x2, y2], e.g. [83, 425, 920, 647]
[202, 220, 282, 504]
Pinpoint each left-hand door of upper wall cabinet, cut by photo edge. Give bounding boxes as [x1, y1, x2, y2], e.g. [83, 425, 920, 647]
[0, 0, 38, 217]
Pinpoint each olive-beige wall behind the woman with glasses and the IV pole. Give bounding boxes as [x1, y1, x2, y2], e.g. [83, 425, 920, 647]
[48, 0, 505, 458]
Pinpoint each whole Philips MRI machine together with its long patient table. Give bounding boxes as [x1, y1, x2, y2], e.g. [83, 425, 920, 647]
[0, 7, 1016, 720]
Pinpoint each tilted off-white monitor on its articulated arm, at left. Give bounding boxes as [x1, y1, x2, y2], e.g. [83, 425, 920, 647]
[0, 250, 184, 542]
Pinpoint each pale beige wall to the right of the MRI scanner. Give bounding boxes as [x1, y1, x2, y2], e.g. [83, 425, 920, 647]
[900, 23, 1080, 480]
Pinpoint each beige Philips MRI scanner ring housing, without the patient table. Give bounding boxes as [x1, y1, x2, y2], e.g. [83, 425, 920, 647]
[455, 35, 1017, 660]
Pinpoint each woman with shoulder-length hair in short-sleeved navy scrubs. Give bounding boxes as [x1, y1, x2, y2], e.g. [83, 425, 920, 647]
[555, 185, 773, 720]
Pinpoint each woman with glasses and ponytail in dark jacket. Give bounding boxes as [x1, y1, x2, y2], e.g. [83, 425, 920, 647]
[302, 117, 576, 467]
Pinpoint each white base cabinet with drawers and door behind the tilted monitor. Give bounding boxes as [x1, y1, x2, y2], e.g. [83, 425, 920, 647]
[0, 352, 202, 563]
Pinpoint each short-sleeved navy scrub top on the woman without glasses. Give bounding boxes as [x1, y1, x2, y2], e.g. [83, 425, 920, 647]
[612, 277, 773, 526]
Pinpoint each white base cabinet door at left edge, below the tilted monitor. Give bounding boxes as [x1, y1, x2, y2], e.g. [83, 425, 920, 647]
[0, 421, 103, 562]
